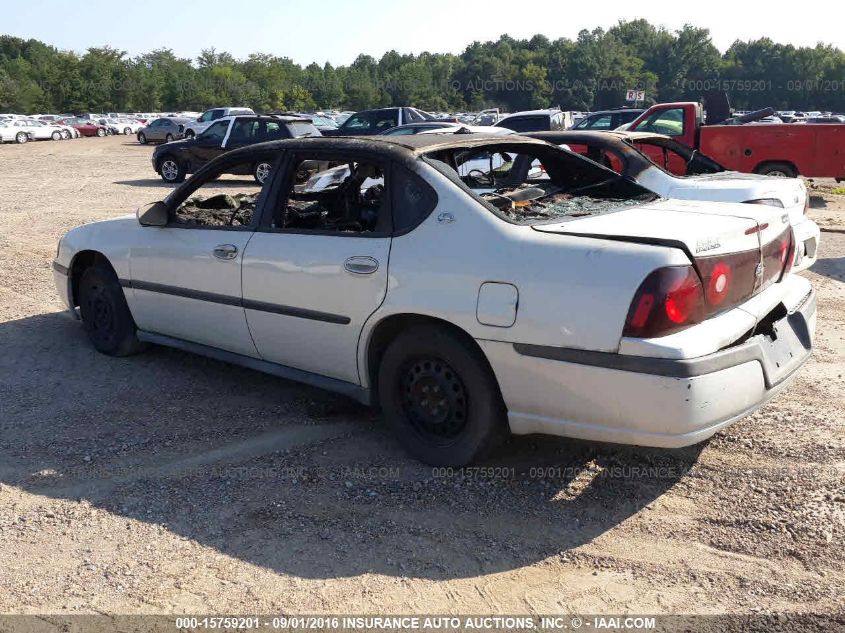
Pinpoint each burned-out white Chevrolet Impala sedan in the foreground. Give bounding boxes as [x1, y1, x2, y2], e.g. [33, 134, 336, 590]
[53, 134, 816, 466]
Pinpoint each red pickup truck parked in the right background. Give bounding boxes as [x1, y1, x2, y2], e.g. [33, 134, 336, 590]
[628, 102, 845, 180]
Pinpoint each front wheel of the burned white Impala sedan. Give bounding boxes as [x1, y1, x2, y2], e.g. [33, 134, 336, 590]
[79, 265, 143, 356]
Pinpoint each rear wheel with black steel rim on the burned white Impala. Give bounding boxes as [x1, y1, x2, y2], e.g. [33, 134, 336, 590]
[378, 325, 508, 467]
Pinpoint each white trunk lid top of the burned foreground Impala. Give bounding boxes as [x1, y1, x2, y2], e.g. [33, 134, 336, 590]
[533, 200, 787, 258]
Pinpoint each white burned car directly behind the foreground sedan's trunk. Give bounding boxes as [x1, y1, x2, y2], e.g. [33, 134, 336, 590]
[528, 130, 821, 271]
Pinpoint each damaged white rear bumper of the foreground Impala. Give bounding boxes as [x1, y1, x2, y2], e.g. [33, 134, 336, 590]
[479, 291, 816, 448]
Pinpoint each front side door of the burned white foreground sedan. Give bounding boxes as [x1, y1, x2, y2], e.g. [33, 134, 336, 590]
[123, 156, 260, 357]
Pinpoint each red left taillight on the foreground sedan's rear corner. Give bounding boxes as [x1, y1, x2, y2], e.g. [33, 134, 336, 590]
[623, 266, 704, 338]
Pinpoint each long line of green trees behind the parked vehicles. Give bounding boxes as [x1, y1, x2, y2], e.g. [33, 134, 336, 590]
[0, 20, 845, 113]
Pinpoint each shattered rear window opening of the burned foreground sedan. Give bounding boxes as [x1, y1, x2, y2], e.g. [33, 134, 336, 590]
[426, 143, 658, 225]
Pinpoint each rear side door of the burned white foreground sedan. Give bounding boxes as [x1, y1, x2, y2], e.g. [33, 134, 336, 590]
[243, 151, 391, 384]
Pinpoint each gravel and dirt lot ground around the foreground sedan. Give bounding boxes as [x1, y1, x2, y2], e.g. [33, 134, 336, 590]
[0, 137, 845, 614]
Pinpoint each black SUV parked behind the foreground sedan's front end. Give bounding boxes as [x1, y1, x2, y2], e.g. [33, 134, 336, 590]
[153, 115, 320, 184]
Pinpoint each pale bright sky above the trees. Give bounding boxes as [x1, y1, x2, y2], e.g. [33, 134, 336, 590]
[0, 0, 845, 65]
